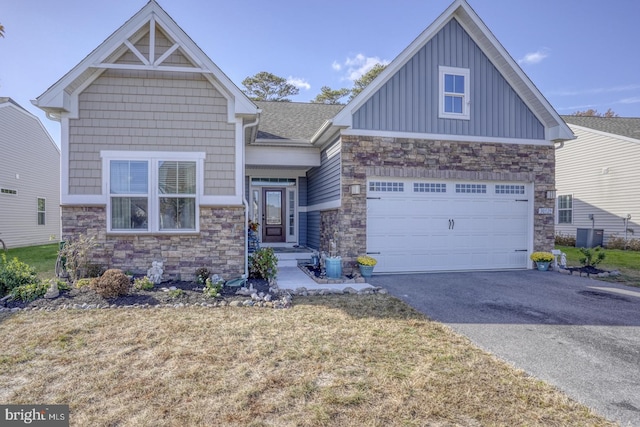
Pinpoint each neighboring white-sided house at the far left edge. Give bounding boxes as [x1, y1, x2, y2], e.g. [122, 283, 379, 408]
[0, 97, 60, 248]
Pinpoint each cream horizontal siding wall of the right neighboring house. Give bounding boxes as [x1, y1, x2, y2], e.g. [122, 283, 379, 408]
[556, 125, 640, 245]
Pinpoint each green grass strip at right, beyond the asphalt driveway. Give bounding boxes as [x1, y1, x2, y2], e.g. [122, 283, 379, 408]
[556, 246, 640, 287]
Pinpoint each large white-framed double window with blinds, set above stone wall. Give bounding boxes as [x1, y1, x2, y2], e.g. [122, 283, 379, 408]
[101, 151, 205, 233]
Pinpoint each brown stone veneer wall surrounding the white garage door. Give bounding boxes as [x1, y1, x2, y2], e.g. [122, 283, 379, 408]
[332, 135, 555, 273]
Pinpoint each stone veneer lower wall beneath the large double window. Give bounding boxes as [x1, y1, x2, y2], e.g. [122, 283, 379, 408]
[62, 206, 245, 280]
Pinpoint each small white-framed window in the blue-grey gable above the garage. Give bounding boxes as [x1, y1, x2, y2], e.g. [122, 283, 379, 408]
[439, 66, 471, 120]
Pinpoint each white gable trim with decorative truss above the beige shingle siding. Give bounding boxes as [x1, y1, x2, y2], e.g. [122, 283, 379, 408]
[32, 0, 257, 121]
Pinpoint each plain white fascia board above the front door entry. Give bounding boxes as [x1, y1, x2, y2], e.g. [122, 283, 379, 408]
[245, 145, 320, 168]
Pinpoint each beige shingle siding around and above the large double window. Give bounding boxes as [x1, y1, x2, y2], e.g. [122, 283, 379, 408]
[69, 70, 236, 195]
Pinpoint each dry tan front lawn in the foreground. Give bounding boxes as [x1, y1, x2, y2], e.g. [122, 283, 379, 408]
[0, 294, 614, 427]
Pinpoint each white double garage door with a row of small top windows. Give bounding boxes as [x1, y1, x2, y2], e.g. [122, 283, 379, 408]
[367, 179, 533, 273]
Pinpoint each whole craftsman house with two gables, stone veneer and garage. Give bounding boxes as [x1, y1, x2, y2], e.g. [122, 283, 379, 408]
[34, 0, 573, 277]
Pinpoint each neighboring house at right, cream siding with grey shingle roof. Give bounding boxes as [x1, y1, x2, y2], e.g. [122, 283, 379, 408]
[556, 116, 640, 245]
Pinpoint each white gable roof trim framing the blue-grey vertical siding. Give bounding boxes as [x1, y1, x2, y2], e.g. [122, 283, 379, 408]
[333, 0, 574, 141]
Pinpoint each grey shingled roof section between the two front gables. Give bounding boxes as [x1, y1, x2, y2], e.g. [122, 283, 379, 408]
[255, 101, 344, 142]
